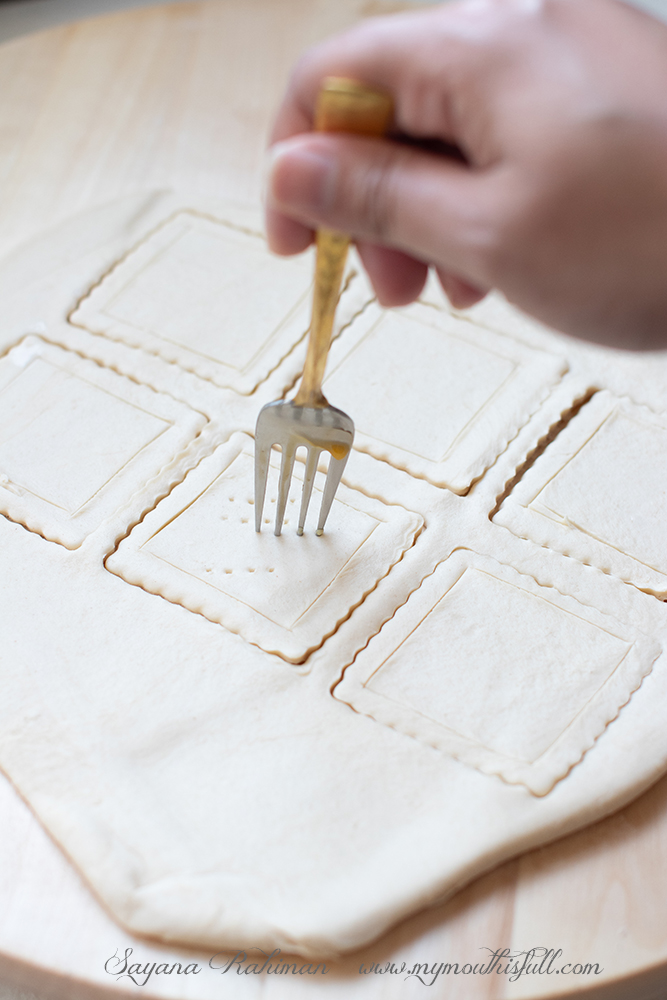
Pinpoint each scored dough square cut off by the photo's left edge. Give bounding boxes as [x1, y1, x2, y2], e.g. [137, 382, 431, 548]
[0, 336, 207, 549]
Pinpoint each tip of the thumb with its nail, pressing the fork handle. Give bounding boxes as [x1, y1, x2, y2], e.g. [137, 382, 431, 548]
[267, 138, 336, 215]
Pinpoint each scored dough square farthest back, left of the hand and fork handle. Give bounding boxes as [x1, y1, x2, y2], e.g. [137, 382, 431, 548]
[70, 211, 320, 394]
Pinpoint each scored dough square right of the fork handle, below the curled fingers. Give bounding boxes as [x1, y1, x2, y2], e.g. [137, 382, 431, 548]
[324, 305, 567, 494]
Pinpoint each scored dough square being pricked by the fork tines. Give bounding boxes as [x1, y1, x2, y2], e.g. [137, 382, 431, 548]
[106, 434, 424, 663]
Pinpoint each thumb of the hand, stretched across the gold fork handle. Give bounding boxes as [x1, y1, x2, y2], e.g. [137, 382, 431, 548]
[267, 133, 496, 287]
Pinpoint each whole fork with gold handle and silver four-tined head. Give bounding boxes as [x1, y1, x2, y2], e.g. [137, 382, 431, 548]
[255, 77, 393, 535]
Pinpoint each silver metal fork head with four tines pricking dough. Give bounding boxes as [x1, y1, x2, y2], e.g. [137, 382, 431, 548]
[255, 400, 354, 535]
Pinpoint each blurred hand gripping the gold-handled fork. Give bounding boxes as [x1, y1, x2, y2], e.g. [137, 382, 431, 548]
[267, 0, 667, 348]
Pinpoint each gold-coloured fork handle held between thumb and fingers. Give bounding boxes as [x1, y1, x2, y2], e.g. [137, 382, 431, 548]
[294, 77, 393, 406]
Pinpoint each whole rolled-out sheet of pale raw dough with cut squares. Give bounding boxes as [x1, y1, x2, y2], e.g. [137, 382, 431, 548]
[0, 196, 667, 956]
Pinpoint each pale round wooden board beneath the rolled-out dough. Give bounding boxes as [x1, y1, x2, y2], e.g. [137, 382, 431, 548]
[0, 0, 667, 1000]
